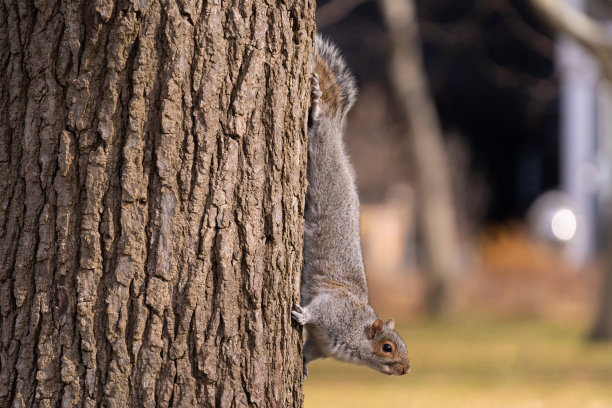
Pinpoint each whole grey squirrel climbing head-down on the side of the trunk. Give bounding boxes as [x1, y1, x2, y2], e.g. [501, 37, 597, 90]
[292, 34, 410, 377]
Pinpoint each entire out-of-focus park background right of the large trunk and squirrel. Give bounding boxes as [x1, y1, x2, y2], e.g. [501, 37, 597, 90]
[305, 0, 612, 407]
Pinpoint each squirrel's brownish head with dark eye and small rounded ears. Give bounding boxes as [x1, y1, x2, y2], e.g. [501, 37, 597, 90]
[366, 319, 410, 375]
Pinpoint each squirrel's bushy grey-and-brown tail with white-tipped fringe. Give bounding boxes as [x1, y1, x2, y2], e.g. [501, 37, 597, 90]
[314, 34, 357, 122]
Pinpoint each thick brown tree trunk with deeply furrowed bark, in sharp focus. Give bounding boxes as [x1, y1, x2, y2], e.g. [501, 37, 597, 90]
[0, 0, 314, 408]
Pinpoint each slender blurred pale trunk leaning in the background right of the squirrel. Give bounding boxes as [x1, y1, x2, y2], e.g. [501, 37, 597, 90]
[379, 0, 462, 317]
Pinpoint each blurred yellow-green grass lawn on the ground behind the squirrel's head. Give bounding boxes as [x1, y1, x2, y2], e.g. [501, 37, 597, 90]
[304, 319, 612, 408]
